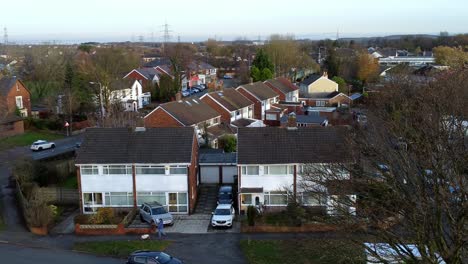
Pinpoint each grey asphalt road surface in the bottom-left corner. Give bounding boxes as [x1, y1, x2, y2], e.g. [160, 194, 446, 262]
[0, 244, 121, 264]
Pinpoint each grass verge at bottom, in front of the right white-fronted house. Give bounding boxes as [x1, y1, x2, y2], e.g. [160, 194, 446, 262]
[241, 239, 365, 264]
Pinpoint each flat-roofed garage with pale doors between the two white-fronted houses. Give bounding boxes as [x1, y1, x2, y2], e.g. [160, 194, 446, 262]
[199, 149, 237, 184]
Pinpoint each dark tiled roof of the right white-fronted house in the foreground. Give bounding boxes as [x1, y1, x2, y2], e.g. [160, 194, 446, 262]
[237, 127, 349, 164]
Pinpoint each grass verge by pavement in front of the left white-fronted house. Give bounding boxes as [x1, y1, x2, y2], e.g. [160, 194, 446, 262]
[73, 240, 171, 258]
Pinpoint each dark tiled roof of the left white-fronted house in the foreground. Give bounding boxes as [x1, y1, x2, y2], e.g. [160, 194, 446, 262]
[76, 127, 195, 164]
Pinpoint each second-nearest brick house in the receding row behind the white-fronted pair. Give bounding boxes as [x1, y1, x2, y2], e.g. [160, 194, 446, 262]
[200, 89, 254, 124]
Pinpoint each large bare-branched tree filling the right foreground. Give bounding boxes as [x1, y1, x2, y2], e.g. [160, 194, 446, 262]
[301, 70, 468, 263]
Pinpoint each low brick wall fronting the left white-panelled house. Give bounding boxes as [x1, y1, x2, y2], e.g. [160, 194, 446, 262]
[75, 223, 156, 235]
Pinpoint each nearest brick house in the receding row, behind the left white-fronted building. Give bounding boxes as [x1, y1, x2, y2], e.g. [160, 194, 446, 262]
[144, 98, 232, 148]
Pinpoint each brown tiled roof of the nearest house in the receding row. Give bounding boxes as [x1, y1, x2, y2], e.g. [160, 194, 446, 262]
[160, 98, 220, 126]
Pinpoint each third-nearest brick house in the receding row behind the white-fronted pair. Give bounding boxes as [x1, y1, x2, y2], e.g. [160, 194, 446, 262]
[236, 82, 279, 121]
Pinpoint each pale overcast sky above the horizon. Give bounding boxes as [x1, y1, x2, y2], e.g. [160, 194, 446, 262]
[0, 0, 468, 42]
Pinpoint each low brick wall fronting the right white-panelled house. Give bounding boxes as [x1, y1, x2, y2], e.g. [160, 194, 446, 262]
[241, 224, 338, 233]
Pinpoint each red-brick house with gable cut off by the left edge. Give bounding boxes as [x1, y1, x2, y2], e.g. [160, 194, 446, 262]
[0, 77, 31, 138]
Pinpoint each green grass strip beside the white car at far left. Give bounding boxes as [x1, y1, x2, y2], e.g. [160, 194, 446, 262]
[0, 131, 63, 150]
